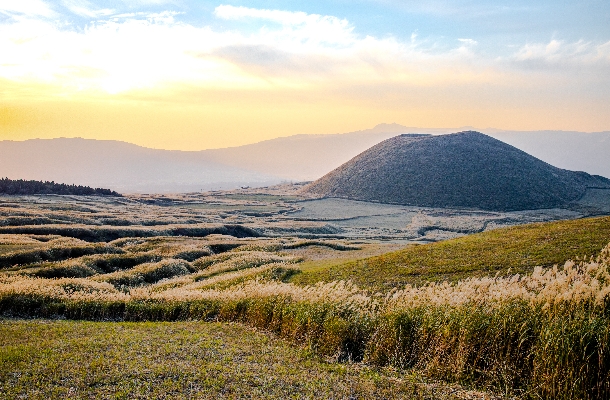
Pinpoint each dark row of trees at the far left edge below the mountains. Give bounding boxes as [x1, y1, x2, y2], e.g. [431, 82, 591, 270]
[0, 178, 121, 197]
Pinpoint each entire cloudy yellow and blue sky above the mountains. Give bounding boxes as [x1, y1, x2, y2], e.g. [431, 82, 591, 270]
[0, 0, 610, 150]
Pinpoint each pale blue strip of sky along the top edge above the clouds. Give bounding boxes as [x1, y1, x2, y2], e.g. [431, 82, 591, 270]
[10, 0, 610, 48]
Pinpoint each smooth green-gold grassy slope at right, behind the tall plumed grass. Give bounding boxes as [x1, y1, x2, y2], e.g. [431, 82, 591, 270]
[293, 217, 610, 289]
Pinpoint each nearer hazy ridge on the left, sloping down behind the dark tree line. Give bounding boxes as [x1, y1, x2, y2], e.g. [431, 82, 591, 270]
[0, 138, 281, 193]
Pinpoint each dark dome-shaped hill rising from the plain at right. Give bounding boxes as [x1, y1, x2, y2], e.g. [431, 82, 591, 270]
[303, 131, 610, 211]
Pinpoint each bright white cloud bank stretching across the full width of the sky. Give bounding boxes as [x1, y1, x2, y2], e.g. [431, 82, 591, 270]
[0, 4, 610, 100]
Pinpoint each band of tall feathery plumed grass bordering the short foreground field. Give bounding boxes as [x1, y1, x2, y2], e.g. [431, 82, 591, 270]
[0, 245, 610, 399]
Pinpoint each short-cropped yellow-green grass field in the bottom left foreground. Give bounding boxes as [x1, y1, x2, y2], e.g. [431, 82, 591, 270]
[0, 320, 483, 399]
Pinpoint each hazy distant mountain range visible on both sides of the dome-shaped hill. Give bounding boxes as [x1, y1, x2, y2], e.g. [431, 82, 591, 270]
[0, 124, 610, 193]
